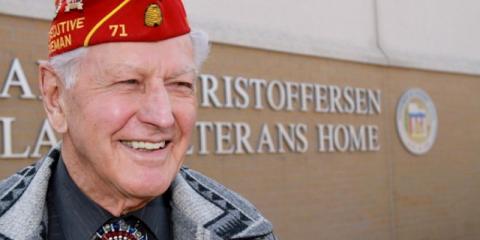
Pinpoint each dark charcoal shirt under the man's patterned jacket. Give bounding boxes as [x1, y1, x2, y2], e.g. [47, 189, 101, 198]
[47, 158, 172, 240]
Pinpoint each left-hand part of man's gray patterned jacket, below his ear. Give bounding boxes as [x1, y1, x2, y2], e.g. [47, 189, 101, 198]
[0, 145, 60, 239]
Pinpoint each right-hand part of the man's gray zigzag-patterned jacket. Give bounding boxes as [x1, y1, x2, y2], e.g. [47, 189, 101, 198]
[171, 168, 272, 239]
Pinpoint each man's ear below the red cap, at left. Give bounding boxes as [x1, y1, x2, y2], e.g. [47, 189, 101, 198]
[38, 63, 67, 134]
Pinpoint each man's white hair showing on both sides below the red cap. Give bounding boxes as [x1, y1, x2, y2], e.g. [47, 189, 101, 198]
[48, 30, 210, 88]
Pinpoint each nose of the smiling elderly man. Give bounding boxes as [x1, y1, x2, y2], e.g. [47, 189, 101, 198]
[138, 84, 175, 128]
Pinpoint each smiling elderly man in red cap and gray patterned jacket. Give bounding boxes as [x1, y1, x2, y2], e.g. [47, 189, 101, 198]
[0, 0, 275, 240]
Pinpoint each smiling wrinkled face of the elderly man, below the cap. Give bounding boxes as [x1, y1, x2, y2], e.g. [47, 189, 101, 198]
[62, 35, 196, 197]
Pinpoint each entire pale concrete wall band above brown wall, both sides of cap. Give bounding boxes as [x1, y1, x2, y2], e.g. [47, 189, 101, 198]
[0, 0, 480, 74]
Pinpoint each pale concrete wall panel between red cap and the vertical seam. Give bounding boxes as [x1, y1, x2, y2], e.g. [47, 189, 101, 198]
[185, 0, 385, 63]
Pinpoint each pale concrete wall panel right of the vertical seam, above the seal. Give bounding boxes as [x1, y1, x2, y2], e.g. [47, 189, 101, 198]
[378, 0, 480, 74]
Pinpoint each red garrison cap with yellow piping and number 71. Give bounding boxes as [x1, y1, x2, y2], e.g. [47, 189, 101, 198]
[48, 0, 190, 57]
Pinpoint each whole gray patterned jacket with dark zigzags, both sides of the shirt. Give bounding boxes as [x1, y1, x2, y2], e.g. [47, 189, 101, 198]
[0, 146, 276, 240]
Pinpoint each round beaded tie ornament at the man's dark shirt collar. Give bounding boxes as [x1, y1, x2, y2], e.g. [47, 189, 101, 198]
[91, 216, 154, 240]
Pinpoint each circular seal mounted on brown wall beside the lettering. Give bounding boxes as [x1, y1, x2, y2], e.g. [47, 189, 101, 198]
[397, 88, 438, 155]
